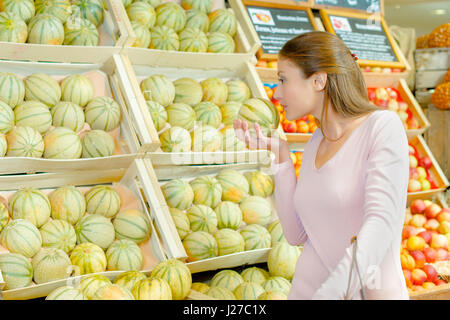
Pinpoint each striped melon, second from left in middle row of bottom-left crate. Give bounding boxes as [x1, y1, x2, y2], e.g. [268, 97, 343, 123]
[39, 219, 77, 253]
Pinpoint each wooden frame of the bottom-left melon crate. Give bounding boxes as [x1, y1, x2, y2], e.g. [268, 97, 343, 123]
[0, 159, 170, 300]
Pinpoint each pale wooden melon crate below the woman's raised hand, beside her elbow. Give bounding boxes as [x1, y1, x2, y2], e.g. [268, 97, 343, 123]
[149, 163, 288, 273]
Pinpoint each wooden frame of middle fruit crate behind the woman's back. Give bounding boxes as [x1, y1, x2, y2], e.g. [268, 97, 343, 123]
[408, 135, 449, 201]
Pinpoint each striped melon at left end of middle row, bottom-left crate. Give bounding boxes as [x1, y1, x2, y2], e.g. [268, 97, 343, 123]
[0, 219, 42, 258]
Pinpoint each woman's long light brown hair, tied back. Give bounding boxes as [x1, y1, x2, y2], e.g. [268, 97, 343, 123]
[279, 31, 378, 140]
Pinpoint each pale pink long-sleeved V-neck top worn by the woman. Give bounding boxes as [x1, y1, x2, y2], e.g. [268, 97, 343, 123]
[272, 110, 409, 299]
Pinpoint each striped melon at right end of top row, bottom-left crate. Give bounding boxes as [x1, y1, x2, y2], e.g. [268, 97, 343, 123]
[85, 185, 121, 218]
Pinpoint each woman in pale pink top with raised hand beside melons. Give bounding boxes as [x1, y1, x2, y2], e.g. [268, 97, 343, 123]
[234, 31, 409, 299]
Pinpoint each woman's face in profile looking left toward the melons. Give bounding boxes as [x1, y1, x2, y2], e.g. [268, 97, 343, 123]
[274, 58, 326, 121]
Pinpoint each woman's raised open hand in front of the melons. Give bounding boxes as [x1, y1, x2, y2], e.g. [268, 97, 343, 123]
[234, 119, 290, 163]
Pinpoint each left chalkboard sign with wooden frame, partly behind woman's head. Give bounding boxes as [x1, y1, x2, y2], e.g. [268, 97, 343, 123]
[243, 1, 316, 60]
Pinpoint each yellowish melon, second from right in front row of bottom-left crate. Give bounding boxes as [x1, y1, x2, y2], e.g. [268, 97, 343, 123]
[70, 242, 107, 276]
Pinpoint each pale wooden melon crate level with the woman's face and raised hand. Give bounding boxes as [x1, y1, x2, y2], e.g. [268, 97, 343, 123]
[121, 51, 285, 165]
